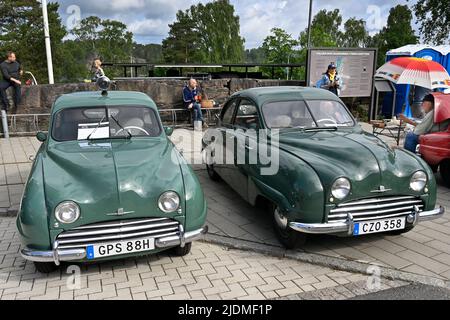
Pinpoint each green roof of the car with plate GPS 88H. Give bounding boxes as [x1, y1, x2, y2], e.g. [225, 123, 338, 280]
[52, 91, 157, 113]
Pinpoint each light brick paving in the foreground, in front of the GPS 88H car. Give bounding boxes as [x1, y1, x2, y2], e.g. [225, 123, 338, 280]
[0, 217, 407, 300]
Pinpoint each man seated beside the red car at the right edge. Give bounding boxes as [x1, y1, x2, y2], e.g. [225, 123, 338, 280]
[399, 94, 450, 153]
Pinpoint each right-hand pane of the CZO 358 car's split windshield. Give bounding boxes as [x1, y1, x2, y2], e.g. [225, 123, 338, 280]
[307, 100, 355, 127]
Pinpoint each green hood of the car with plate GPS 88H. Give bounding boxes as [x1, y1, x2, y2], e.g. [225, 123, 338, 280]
[43, 138, 184, 227]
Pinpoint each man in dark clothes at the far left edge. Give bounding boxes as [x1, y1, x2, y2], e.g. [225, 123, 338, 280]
[0, 52, 23, 110]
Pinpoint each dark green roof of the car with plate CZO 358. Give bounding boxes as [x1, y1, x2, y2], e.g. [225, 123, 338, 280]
[232, 86, 341, 106]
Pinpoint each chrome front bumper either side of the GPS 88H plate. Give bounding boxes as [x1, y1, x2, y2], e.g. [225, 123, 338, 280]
[21, 226, 208, 265]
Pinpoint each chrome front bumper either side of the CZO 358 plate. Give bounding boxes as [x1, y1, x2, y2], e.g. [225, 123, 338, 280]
[289, 207, 445, 235]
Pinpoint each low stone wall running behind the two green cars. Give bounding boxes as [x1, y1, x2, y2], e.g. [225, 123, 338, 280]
[3, 79, 302, 114]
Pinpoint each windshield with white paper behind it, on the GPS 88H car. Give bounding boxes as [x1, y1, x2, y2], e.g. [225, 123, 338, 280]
[52, 106, 162, 141]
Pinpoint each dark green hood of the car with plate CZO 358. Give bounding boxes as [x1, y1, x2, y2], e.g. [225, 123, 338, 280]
[280, 130, 424, 198]
